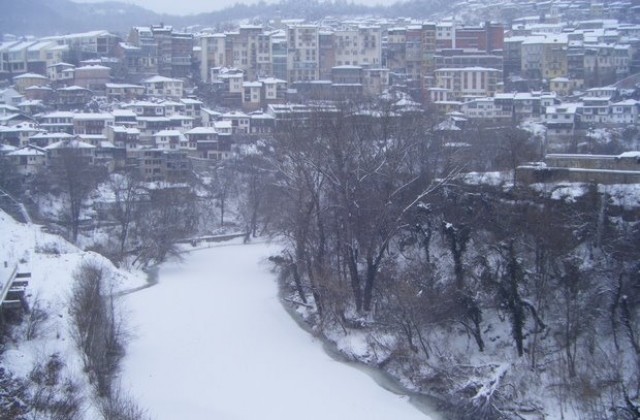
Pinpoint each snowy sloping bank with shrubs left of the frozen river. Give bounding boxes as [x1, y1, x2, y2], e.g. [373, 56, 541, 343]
[0, 210, 146, 419]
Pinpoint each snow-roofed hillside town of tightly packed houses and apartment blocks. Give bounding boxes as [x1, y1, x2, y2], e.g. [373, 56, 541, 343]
[0, 1, 640, 169]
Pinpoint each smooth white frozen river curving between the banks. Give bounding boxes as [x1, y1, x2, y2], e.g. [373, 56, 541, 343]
[122, 241, 436, 420]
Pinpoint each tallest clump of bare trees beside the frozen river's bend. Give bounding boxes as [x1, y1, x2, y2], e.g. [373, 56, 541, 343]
[264, 104, 456, 318]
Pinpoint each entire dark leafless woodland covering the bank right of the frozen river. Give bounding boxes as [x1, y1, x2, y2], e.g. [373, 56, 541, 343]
[265, 107, 640, 418]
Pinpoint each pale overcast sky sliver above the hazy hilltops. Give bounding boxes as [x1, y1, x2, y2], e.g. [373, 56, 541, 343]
[73, 0, 384, 15]
